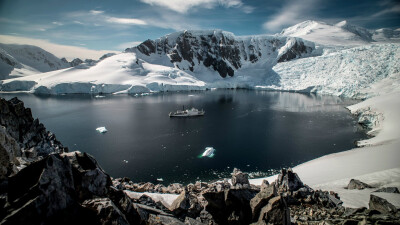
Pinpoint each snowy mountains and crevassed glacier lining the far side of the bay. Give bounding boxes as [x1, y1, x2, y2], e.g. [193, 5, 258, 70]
[0, 21, 400, 97]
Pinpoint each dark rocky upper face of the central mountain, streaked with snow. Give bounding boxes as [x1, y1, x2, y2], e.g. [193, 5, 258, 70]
[125, 30, 315, 78]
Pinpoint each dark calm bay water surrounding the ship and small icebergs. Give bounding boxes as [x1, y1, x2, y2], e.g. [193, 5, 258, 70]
[0, 90, 366, 183]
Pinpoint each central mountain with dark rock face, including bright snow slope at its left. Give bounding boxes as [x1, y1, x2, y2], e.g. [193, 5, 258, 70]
[1, 30, 318, 94]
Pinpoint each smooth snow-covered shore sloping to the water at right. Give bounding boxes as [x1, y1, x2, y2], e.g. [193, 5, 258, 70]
[250, 88, 400, 208]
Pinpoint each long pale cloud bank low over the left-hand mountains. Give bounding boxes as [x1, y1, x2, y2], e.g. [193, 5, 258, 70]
[0, 35, 117, 61]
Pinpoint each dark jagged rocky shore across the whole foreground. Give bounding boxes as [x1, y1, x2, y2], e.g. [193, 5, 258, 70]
[0, 98, 400, 224]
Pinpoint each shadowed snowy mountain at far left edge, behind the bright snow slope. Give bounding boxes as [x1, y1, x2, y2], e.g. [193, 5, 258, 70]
[0, 44, 69, 79]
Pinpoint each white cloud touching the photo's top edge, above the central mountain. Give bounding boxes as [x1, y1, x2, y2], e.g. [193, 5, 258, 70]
[140, 0, 254, 13]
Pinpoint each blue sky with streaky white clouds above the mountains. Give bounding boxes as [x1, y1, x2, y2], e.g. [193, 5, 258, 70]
[0, 0, 400, 59]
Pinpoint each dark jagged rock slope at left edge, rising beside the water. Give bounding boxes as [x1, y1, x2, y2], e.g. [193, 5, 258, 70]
[0, 98, 68, 178]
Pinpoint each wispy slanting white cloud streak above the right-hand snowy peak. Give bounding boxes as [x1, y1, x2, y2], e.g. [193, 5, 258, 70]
[263, 0, 319, 31]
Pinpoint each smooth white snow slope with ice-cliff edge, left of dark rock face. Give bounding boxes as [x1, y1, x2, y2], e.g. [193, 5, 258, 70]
[2, 53, 205, 94]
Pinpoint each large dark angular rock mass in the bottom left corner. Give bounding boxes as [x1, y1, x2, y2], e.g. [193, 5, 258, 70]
[2, 152, 111, 224]
